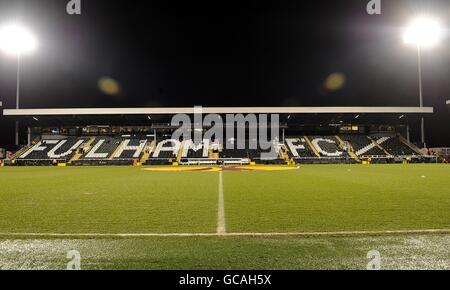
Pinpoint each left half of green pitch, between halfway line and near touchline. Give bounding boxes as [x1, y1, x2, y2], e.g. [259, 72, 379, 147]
[0, 167, 217, 233]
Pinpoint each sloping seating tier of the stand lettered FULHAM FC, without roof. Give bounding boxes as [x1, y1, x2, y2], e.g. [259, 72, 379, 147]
[10, 134, 427, 165]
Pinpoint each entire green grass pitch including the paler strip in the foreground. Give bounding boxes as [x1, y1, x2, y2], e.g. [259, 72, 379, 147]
[0, 164, 450, 269]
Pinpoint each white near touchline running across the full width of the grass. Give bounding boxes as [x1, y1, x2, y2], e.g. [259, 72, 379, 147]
[0, 229, 450, 239]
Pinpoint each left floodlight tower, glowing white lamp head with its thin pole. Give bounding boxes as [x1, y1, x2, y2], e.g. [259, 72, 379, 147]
[0, 23, 37, 145]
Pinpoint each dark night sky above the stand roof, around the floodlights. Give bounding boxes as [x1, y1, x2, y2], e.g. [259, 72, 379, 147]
[0, 0, 450, 146]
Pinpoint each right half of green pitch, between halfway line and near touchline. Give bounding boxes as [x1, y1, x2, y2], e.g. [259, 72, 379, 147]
[224, 164, 450, 232]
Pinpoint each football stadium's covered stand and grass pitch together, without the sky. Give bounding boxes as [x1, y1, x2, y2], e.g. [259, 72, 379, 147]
[0, 107, 450, 269]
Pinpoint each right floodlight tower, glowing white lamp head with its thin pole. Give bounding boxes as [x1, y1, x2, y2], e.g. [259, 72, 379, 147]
[403, 16, 442, 147]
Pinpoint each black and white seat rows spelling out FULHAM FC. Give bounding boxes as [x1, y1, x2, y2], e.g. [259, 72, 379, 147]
[18, 134, 420, 162]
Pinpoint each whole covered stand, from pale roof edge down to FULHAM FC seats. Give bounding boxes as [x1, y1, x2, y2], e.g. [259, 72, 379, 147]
[0, 107, 436, 166]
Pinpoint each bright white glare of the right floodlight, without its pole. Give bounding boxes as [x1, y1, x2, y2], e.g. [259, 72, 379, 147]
[403, 17, 442, 47]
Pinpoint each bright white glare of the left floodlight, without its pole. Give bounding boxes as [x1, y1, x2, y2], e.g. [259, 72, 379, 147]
[0, 24, 37, 55]
